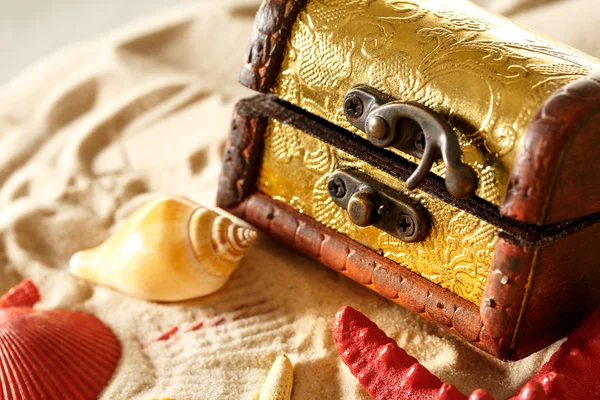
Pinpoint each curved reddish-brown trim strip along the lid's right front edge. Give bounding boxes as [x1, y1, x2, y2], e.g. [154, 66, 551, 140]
[500, 73, 600, 225]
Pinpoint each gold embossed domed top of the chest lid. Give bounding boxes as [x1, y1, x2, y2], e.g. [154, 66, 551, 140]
[242, 0, 600, 205]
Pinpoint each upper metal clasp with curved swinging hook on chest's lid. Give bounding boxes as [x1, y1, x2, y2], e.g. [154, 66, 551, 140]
[344, 85, 477, 198]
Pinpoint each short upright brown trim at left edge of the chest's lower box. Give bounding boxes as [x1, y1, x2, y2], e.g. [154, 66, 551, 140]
[217, 101, 268, 208]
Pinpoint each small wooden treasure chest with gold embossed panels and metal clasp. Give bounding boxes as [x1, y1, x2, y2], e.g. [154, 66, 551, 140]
[218, 0, 600, 360]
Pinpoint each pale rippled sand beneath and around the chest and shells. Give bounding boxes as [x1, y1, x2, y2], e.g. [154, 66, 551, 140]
[0, 0, 600, 399]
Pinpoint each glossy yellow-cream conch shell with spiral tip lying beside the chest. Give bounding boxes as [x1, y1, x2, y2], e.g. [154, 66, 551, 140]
[70, 197, 257, 301]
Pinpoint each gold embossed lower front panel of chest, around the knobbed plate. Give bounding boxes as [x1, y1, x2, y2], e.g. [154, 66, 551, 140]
[258, 120, 496, 305]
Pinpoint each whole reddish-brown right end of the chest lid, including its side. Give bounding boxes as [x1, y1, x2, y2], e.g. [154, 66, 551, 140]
[500, 74, 600, 225]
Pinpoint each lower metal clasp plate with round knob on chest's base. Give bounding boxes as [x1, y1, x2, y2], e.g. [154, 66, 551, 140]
[327, 168, 430, 242]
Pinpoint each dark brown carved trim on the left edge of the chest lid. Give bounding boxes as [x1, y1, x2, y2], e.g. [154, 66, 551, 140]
[240, 0, 308, 93]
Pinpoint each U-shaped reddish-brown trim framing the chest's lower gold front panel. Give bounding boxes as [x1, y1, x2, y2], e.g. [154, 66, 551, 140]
[217, 95, 552, 360]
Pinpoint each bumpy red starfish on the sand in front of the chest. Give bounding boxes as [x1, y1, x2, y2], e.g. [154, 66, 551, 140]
[332, 307, 600, 400]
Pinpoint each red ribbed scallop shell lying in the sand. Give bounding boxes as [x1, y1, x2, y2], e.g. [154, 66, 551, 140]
[0, 282, 121, 400]
